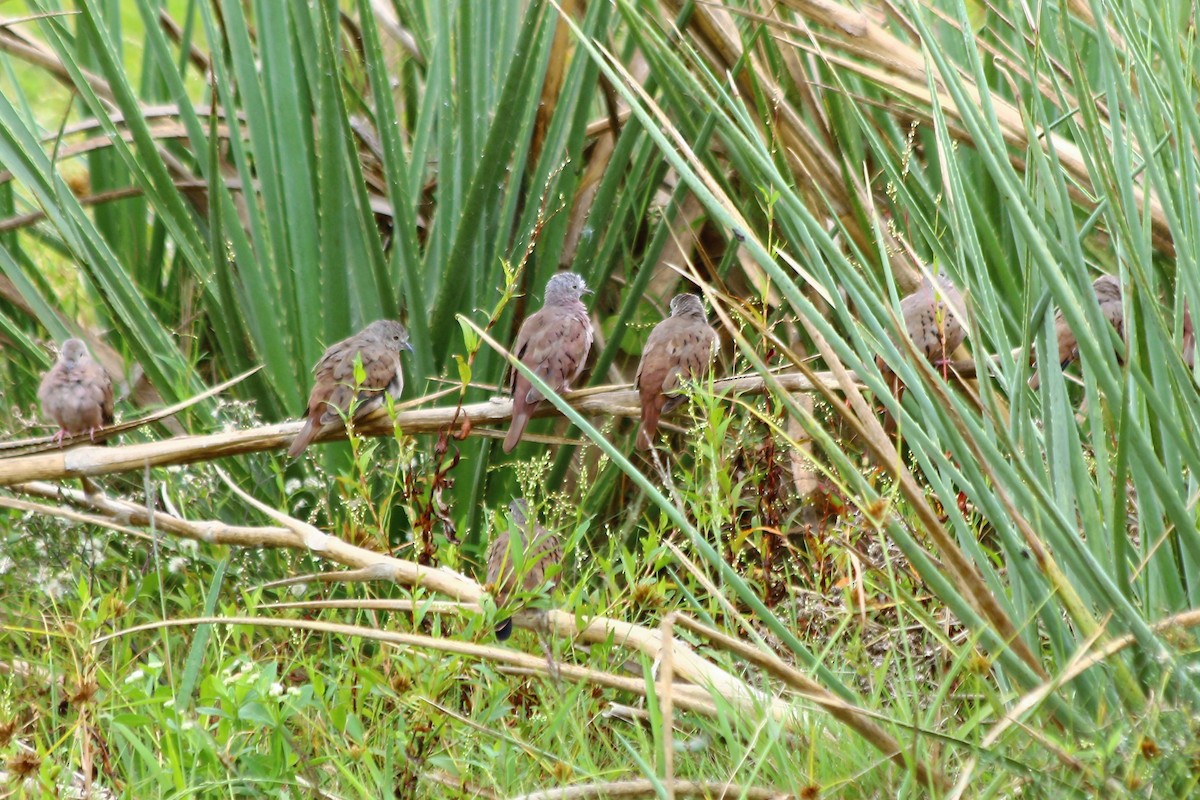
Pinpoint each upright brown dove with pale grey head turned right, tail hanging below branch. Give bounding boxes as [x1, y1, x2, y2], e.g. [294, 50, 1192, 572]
[504, 272, 592, 452]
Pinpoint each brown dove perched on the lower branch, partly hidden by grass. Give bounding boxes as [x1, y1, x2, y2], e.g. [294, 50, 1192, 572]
[487, 498, 563, 642]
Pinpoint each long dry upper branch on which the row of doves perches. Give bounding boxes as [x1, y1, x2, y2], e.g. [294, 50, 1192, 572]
[0, 373, 835, 486]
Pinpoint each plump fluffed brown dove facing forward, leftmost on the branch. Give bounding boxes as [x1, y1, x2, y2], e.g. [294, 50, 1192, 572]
[37, 339, 113, 445]
